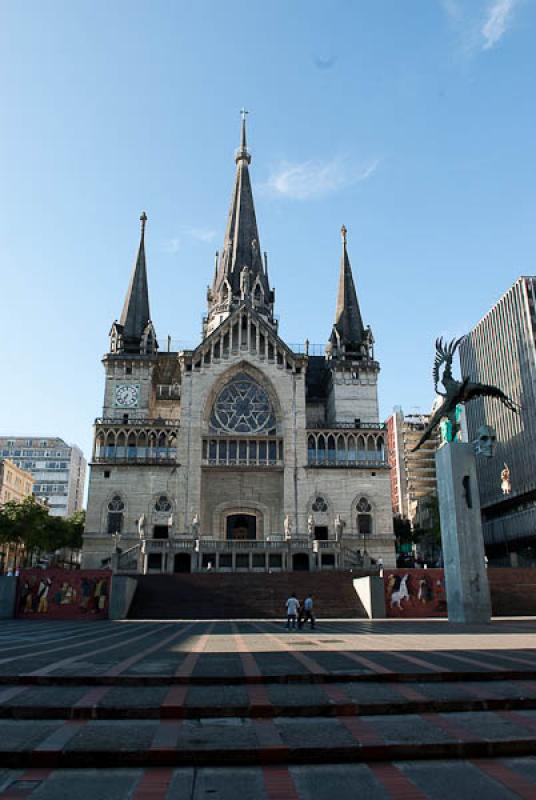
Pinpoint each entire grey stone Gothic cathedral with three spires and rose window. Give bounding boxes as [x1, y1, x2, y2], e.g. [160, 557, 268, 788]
[82, 120, 395, 572]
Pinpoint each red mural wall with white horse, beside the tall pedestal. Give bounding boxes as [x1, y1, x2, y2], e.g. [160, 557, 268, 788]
[383, 569, 447, 617]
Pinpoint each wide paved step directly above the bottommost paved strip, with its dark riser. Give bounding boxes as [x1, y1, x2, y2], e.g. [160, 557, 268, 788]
[0, 710, 536, 768]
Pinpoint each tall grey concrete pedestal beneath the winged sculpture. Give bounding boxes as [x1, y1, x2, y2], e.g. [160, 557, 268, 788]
[436, 442, 491, 623]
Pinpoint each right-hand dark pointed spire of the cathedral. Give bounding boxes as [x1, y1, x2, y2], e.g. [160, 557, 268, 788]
[330, 225, 367, 353]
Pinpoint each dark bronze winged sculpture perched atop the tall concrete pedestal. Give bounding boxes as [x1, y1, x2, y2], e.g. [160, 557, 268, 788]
[412, 336, 520, 452]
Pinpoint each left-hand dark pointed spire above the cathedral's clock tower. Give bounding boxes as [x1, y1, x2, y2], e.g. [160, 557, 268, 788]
[112, 211, 154, 353]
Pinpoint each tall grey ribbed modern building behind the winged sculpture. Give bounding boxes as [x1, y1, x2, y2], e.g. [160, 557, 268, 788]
[460, 276, 536, 566]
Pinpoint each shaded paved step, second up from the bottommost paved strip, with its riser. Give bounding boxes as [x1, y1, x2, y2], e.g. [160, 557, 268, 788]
[0, 681, 536, 720]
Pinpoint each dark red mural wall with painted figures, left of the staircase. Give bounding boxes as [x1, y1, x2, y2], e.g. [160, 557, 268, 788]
[16, 569, 112, 619]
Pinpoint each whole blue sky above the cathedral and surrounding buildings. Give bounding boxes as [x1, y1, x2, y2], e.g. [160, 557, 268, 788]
[0, 0, 536, 468]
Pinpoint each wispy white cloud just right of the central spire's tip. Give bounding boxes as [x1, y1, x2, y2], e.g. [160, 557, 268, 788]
[263, 158, 380, 200]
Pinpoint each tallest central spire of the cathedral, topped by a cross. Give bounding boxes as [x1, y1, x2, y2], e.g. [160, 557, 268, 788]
[206, 109, 273, 333]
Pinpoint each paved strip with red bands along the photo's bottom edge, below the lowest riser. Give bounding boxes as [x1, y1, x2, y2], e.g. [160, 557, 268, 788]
[0, 756, 536, 800]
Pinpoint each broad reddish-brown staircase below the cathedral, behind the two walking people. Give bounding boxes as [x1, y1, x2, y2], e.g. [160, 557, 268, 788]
[129, 570, 368, 619]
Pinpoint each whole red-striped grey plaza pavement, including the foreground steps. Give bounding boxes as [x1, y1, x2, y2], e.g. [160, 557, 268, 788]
[0, 618, 536, 800]
